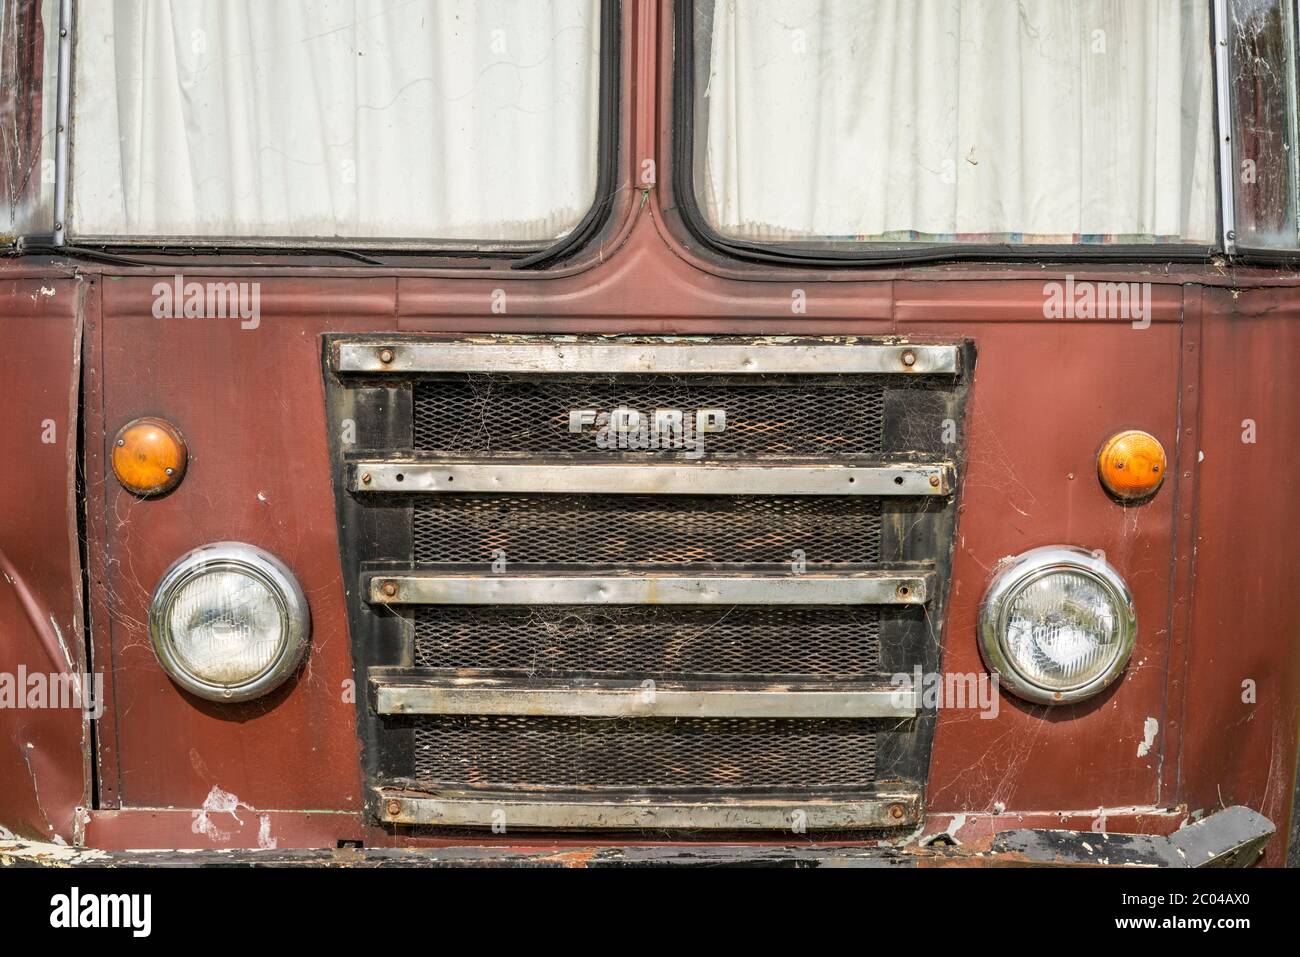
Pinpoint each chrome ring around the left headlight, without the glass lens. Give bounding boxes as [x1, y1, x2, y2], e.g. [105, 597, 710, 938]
[150, 542, 311, 702]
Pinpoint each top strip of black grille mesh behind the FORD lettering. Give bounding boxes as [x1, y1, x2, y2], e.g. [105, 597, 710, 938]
[415, 376, 885, 456]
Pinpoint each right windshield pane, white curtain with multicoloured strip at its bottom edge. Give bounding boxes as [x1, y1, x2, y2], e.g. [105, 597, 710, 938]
[693, 0, 1218, 246]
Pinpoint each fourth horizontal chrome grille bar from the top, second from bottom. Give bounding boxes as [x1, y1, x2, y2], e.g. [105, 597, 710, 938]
[371, 675, 918, 719]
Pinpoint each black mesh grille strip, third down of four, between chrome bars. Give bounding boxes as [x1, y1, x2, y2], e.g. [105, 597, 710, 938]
[415, 605, 880, 676]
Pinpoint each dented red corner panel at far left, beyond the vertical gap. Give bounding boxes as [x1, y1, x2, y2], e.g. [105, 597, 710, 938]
[0, 269, 90, 840]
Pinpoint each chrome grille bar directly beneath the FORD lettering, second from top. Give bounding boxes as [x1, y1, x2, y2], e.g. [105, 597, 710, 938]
[348, 459, 953, 495]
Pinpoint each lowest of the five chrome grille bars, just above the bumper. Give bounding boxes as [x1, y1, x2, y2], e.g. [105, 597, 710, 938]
[374, 787, 920, 832]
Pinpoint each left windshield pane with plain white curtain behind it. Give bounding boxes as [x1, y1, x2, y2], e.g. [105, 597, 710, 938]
[70, 0, 601, 244]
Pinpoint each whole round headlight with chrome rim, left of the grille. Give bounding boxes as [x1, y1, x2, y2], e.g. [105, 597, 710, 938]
[150, 542, 309, 701]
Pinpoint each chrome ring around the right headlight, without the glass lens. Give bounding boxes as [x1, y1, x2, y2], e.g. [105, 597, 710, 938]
[979, 545, 1138, 705]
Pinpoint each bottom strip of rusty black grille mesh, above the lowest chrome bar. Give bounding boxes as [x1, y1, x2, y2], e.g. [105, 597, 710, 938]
[411, 715, 876, 792]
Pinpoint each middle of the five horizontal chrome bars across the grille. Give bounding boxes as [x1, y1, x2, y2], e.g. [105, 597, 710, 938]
[365, 571, 933, 605]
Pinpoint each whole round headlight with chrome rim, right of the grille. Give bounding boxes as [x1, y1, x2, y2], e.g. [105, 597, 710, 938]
[980, 546, 1138, 705]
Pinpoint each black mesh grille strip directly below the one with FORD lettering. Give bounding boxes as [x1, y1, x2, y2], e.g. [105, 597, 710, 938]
[412, 495, 880, 566]
